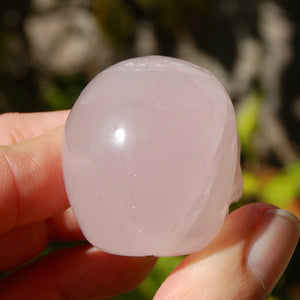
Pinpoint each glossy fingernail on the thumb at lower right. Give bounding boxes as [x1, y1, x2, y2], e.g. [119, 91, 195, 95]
[247, 209, 300, 294]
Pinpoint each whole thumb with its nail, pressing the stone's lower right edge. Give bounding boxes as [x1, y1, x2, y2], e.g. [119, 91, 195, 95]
[154, 203, 300, 300]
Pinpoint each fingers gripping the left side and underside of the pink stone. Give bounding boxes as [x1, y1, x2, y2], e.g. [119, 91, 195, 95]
[0, 111, 156, 300]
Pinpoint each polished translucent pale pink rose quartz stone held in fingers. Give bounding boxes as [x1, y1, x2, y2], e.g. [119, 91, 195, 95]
[62, 56, 242, 256]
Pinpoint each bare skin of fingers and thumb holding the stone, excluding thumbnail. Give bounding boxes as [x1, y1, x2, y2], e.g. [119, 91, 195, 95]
[0, 111, 299, 300]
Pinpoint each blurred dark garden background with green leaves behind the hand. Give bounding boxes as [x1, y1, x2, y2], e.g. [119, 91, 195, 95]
[0, 0, 300, 300]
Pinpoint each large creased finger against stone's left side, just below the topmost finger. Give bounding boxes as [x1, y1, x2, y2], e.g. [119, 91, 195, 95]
[0, 111, 69, 233]
